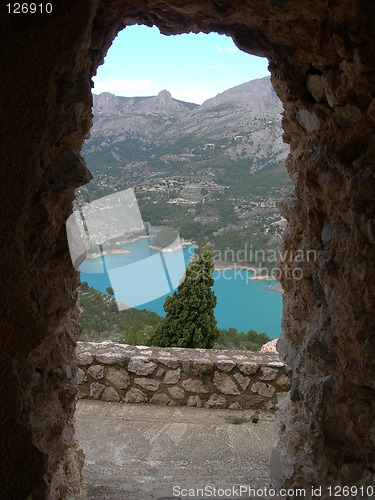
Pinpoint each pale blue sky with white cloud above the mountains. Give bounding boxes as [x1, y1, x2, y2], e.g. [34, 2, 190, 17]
[93, 26, 269, 104]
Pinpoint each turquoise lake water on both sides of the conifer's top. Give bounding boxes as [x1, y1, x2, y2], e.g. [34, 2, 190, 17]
[80, 238, 282, 338]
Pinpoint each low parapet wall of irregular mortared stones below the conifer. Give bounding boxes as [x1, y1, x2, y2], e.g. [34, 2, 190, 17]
[77, 342, 290, 410]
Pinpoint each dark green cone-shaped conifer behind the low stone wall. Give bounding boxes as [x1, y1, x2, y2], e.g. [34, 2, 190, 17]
[149, 244, 219, 349]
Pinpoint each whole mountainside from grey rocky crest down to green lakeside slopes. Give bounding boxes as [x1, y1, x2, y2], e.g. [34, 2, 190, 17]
[76, 78, 291, 264]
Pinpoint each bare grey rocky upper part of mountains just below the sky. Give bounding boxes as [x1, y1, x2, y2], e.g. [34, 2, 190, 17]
[84, 77, 287, 169]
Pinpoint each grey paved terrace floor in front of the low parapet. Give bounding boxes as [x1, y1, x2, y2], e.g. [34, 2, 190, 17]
[76, 400, 275, 500]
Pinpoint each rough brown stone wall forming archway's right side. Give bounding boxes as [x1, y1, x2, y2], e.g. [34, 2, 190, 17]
[271, 8, 375, 498]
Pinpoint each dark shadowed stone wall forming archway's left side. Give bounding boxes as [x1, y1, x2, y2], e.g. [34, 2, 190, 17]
[0, 2, 97, 499]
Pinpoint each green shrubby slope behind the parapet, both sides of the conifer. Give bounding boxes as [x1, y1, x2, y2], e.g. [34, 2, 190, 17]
[78, 282, 270, 351]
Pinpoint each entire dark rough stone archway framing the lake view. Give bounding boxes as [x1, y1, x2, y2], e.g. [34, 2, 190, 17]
[0, 0, 375, 498]
